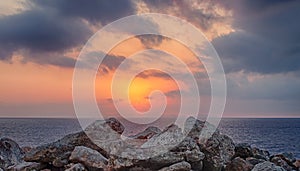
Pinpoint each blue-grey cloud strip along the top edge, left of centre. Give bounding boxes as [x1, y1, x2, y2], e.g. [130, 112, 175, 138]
[32, 0, 135, 24]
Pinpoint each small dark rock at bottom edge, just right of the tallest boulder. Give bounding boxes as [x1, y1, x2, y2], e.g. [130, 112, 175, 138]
[225, 157, 253, 171]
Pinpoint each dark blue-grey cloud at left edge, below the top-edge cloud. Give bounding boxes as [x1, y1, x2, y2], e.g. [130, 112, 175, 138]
[0, 10, 91, 67]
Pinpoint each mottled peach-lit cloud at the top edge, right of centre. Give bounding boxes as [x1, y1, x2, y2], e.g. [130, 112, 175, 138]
[143, 0, 231, 38]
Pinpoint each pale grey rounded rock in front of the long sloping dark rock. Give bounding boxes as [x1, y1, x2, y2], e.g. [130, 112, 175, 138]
[69, 146, 108, 169]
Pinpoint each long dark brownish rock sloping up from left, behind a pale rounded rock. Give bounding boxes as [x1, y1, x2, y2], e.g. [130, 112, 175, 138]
[24, 132, 105, 166]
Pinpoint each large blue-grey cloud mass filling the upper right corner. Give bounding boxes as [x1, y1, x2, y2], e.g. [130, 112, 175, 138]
[212, 1, 300, 74]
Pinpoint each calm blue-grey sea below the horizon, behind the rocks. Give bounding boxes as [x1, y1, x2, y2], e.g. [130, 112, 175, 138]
[0, 119, 300, 158]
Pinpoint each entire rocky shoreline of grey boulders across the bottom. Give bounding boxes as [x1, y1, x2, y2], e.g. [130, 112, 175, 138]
[0, 117, 300, 171]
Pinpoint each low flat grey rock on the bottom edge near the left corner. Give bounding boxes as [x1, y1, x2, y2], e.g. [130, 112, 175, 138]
[7, 162, 46, 171]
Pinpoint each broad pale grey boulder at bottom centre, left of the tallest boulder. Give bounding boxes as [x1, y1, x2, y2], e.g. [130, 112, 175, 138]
[112, 122, 204, 170]
